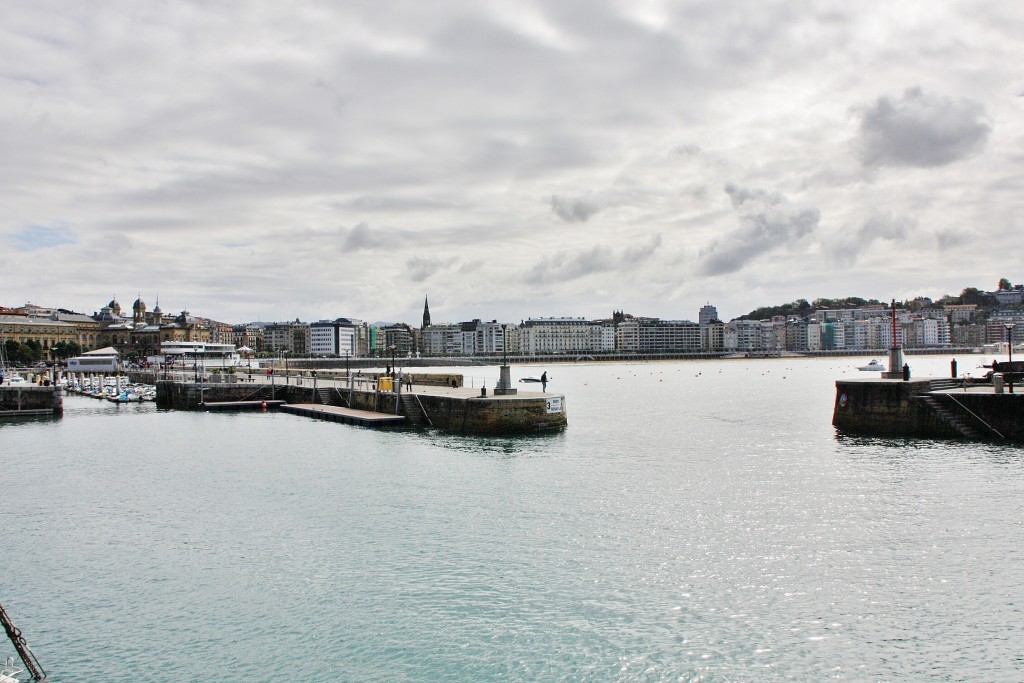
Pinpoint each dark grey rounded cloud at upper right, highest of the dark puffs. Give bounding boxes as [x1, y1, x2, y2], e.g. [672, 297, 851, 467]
[857, 88, 992, 168]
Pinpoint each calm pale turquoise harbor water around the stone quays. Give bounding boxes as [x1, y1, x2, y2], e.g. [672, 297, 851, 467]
[0, 356, 1024, 682]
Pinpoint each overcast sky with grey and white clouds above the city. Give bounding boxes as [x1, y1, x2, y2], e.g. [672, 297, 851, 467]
[0, 0, 1024, 323]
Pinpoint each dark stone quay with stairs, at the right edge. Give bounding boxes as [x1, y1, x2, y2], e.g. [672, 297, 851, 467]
[833, 373, 1024, 443]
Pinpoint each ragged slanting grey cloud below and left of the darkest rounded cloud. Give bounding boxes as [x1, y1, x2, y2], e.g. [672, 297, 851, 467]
[698, 183, 821, 275]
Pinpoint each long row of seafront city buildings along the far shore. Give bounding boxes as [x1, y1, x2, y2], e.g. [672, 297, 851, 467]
[0, 290, 1024, 359]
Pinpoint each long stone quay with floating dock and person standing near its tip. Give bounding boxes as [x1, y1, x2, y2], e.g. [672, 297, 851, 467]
[157, 371, 568, 435]
